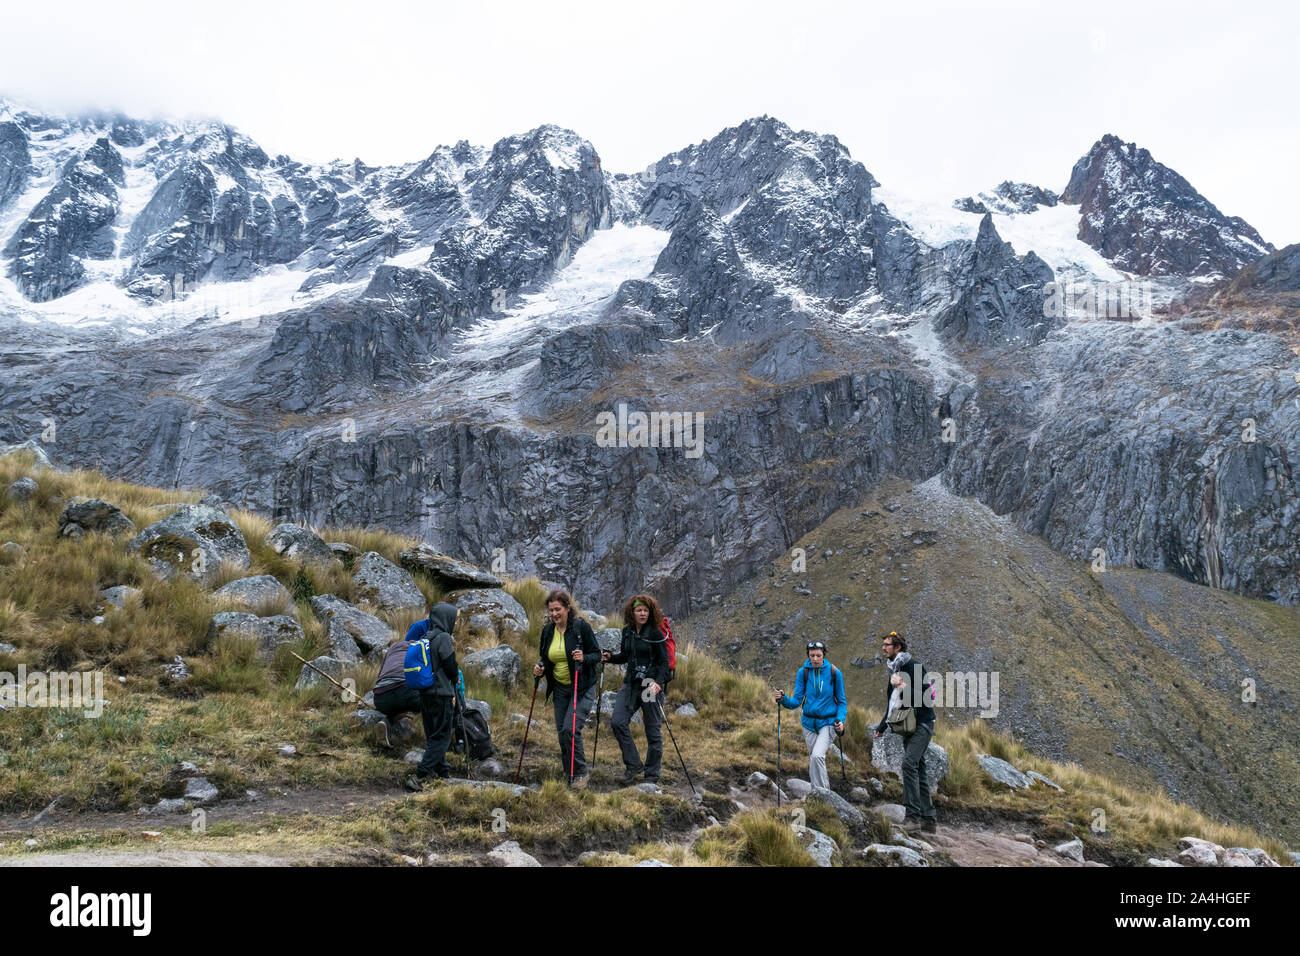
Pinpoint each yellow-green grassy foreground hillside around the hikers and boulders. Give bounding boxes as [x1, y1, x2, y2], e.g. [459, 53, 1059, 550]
[0, 455, 1286, 865]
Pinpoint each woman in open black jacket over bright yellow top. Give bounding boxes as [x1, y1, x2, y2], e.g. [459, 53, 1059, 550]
[533, 588, 601, 790]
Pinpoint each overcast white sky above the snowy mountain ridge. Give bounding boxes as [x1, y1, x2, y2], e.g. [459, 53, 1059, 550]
[0, 0, 1300, 246]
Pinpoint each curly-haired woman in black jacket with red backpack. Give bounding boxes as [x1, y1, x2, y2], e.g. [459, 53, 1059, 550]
[602, 594, 668, 787]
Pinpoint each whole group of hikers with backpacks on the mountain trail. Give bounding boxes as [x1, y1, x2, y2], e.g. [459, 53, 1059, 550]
[374, 588, 935, 831]
